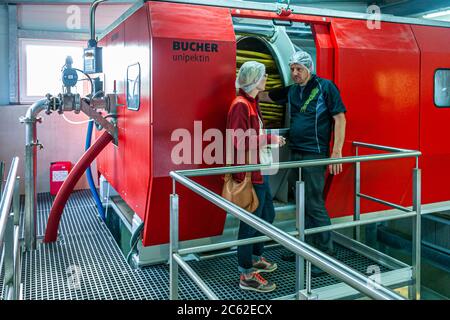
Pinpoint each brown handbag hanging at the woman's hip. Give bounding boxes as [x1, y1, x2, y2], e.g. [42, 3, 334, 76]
[222, 172, 259, 212]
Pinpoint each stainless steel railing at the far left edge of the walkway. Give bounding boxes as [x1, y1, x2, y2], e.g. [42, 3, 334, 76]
[0, 157, 21, 300]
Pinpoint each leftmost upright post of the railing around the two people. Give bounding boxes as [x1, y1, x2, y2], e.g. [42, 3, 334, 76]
[169, 180, 179, 300]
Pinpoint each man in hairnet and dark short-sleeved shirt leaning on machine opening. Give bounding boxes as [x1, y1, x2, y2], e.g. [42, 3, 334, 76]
[259, 51, 346, 275]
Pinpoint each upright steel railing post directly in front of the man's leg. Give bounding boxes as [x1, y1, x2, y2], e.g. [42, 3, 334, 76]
[295, 168, 305, 299]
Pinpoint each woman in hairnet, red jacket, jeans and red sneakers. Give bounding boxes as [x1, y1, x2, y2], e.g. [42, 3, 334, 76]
[227, 61, 285, 292]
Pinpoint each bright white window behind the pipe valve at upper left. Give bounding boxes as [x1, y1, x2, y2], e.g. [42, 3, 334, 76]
[19, 39, 90, 103]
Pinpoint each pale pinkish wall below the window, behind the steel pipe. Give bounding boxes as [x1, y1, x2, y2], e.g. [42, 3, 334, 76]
[0, 105, 97, 193]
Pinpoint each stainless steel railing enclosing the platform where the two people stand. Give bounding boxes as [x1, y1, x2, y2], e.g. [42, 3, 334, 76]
[170, 142, 421, 300]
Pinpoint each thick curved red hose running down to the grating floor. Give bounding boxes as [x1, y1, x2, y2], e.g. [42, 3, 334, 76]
[44, 131, 113, 243]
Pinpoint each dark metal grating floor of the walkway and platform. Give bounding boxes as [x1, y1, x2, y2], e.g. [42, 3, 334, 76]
[10, 190, 387, 300]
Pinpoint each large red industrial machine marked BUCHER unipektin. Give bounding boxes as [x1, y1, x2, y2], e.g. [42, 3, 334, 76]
[92, 1, 450, 260]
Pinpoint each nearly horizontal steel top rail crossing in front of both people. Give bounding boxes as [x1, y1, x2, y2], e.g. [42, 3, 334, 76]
[176, 151, 422, 177]
